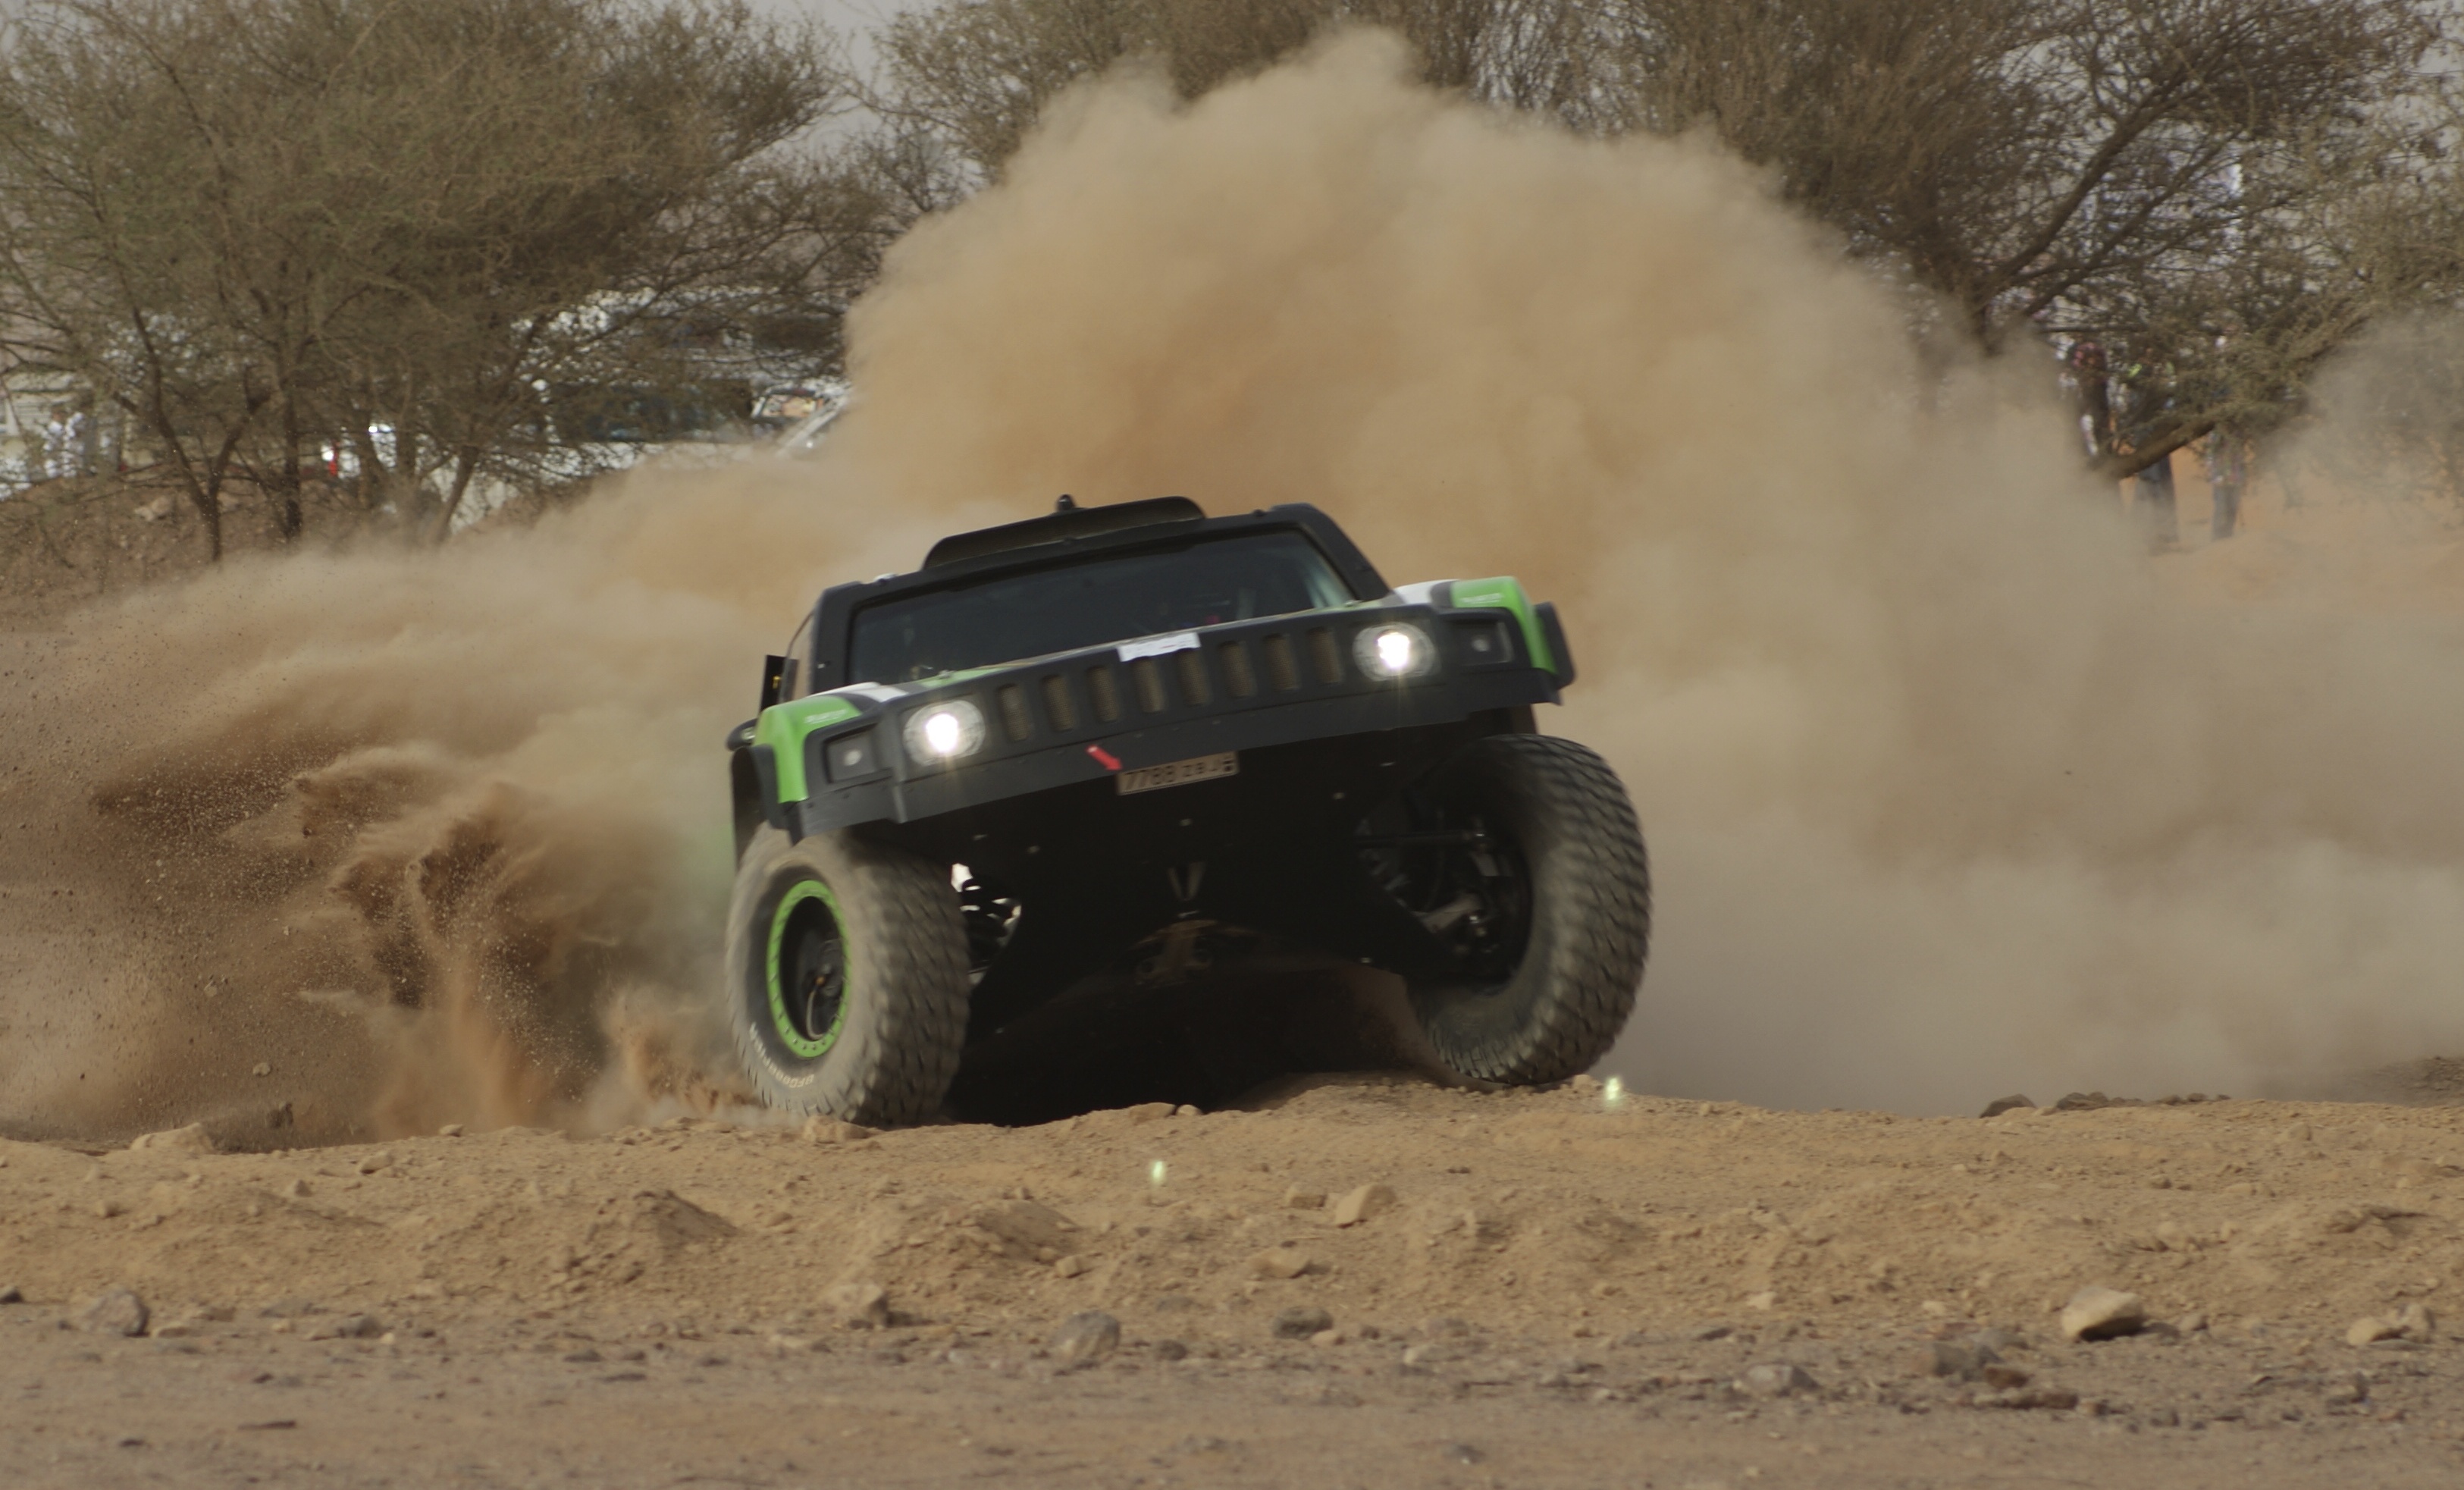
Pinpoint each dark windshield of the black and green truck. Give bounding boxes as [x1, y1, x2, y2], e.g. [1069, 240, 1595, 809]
[848, 529, 1353, 682]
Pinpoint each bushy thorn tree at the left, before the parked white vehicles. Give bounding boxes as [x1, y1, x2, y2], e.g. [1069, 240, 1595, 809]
[0, 0, 887, 547]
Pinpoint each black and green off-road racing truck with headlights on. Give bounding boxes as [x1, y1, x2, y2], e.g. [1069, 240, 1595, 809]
[727, 497, 1651, 1123]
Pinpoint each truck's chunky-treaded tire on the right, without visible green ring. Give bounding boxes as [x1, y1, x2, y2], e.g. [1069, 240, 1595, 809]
[1412, 734, 1651, 1086]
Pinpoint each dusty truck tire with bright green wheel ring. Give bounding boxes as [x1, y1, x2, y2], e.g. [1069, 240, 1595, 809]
[727, 825, 968, 1128]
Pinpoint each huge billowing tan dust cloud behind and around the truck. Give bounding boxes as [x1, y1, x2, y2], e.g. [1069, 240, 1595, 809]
[0, 34, 2464, 1140]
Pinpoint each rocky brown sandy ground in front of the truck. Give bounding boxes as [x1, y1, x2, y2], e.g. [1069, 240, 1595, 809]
[0, 1079, 2464, 1488]
